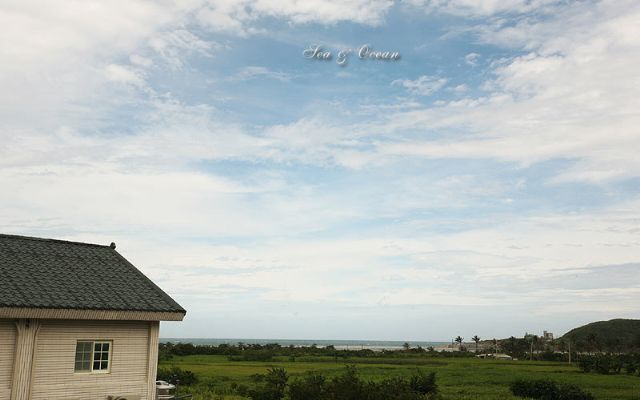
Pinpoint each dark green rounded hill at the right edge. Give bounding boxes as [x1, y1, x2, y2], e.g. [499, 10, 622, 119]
[562, 319, 640, 352]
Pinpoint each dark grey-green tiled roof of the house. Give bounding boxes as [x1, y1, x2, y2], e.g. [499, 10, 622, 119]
[0, 234, 185, 313]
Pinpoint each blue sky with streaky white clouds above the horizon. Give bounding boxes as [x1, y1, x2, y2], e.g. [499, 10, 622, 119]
[0, 0, 640, 341]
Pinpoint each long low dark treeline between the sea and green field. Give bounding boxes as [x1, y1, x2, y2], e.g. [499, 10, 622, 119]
[159, 342, 474, 361]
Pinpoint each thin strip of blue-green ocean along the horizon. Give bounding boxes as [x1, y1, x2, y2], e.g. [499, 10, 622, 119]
[160, 338, 450, 351]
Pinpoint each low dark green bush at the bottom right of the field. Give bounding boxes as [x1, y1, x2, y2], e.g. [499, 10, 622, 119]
[510, 379, 594, 400]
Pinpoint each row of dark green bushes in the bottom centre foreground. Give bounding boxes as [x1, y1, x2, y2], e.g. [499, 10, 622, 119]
[236, 366, 438, 400]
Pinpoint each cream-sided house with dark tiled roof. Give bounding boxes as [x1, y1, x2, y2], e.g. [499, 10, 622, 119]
[0, 235, 186, 400]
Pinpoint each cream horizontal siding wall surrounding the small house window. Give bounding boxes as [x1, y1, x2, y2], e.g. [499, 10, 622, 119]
[31, 320, 150, 400]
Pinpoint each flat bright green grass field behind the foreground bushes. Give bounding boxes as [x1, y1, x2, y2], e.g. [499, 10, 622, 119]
[160, 356, 640, 400]
